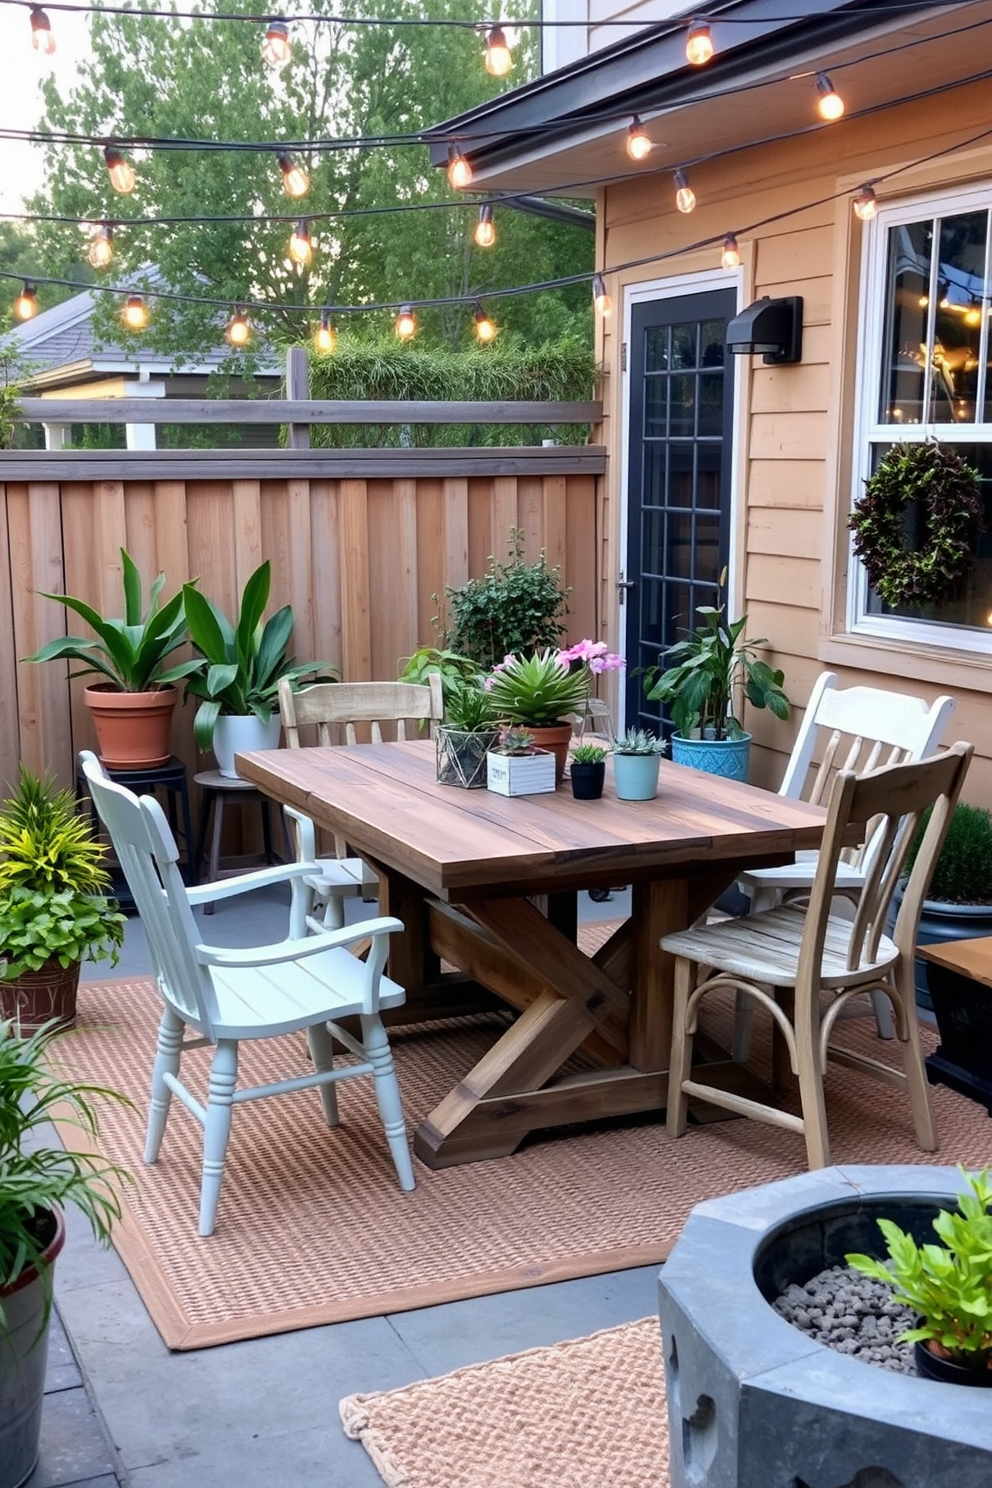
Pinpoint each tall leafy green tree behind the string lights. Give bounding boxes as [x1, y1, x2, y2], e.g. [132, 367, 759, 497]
[31, 0, 593, 356]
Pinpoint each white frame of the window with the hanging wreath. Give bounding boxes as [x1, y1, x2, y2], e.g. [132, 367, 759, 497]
[846, 183, 992, 656]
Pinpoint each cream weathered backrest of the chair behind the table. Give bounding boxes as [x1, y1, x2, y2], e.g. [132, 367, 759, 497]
[280, 673, 445, 748]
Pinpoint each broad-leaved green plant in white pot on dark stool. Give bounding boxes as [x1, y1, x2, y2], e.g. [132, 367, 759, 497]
[181, 558, 332, 780]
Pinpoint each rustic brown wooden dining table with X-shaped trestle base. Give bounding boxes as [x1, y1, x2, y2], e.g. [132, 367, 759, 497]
[236, 740, 825, 1168]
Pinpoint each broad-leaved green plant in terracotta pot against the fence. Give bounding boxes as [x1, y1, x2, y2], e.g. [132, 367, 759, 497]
[24, 548, 198, 769]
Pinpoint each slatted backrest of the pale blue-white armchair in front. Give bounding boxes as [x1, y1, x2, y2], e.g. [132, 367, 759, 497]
[79, 750, 217, 1037]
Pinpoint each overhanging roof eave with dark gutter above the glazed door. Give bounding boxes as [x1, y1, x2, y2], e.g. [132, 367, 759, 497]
[424, 0, 992, 196]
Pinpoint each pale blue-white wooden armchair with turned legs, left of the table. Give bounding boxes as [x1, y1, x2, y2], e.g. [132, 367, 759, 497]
[80, 750, 413, 1235]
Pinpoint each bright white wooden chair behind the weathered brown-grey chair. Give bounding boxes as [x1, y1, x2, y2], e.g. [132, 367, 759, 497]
[733, 671, 955, 1061]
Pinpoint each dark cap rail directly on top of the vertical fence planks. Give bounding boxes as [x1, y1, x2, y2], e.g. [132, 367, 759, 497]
[0, 445, 607, 482]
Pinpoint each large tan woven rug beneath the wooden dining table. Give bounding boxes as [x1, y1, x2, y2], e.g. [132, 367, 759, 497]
[58, 927, 989, 1348]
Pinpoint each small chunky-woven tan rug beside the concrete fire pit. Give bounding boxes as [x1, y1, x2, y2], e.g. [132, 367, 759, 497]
[341, 1317, 668, 1488]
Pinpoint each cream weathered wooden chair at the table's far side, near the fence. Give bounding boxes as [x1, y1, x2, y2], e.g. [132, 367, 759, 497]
[273, 674, 445, 930]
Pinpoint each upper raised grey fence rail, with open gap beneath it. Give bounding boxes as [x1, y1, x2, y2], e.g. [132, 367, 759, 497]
[12, 397, 602, 424]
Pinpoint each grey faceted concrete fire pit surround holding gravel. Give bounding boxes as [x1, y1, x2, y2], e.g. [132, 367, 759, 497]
[660, 1165, 992, 1488]
